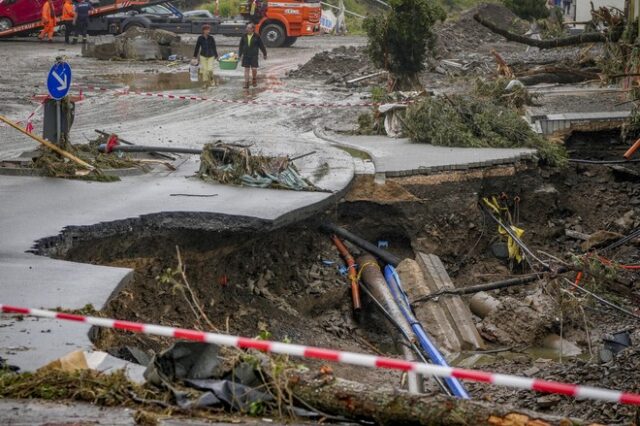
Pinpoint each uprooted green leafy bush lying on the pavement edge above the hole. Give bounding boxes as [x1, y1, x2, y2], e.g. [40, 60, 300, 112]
[405, 96, 567, 166]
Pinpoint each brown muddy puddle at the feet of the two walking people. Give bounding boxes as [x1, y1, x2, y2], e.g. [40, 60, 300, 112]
[102, 71, 225, 91]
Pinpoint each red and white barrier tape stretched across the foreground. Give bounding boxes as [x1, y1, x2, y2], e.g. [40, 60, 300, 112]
[0, 305, 640, 405]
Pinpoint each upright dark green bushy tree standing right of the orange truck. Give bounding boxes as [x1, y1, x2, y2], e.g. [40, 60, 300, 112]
[364, 0, 446, 90]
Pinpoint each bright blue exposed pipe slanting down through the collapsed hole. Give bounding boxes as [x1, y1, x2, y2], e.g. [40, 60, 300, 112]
[384, 265, 469, 399]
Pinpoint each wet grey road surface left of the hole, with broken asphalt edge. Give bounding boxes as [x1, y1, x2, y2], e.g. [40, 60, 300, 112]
[0, 34, 361, 369]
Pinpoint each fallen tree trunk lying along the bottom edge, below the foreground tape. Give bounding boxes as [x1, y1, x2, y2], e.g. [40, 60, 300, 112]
[288, 371, 584, 426]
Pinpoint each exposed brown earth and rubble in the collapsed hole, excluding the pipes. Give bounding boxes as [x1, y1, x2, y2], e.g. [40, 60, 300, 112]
[47, 134, 640, 423]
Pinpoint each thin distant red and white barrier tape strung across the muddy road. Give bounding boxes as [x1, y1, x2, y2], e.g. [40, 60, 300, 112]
[77, 86, 402, 108]
